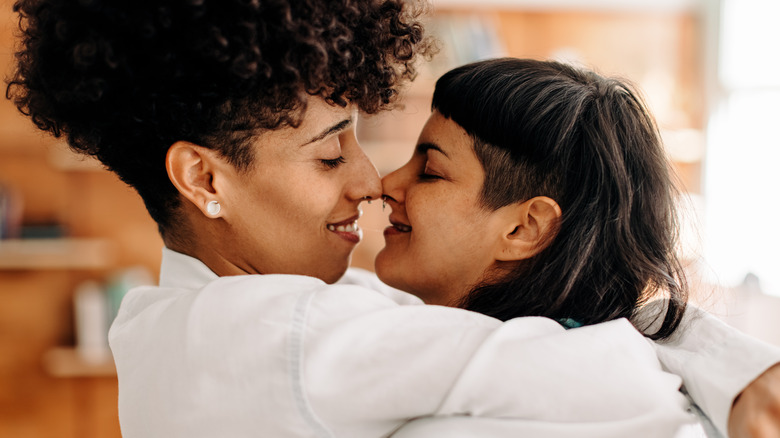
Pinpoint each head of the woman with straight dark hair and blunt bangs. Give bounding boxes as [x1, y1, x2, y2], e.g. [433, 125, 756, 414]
[376, 58, 777, 436]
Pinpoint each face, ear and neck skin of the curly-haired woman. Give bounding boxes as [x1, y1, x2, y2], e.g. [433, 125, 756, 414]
[167, 98, 381, 283]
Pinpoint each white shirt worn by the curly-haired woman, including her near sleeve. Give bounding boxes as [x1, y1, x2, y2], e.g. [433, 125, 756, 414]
[109, 249, 780, 438]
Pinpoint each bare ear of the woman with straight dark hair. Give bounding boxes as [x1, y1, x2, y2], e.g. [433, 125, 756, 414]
[496, 196, 562, 261]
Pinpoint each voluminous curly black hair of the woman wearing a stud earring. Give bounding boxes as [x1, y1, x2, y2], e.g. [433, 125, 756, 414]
[6, 0, 433, 235]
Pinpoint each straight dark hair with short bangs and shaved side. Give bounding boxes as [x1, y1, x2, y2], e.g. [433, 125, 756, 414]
[433, 58, 688, 339]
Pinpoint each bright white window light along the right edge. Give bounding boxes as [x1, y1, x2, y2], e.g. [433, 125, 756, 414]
[703, 0, 780, 296]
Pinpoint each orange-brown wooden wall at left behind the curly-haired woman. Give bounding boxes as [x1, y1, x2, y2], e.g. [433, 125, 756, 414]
[0, 0, 162, 438]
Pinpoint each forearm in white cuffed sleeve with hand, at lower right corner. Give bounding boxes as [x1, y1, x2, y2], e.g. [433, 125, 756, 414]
[640, 307, 780, 438]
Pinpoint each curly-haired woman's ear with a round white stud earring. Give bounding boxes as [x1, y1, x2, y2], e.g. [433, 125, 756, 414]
[165, 141, 222, 218]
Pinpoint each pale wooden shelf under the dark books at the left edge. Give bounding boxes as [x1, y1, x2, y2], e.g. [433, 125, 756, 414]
[0, 239, 113, 270]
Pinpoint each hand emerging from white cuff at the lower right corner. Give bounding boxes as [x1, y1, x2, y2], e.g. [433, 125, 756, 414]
[728, 363, 780, 438]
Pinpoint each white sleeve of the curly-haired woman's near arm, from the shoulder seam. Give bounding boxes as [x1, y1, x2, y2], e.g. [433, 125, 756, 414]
[301, 286, 688, 437]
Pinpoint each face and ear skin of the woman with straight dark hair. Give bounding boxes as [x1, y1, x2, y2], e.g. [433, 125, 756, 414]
[375, 111, 560, 306]
